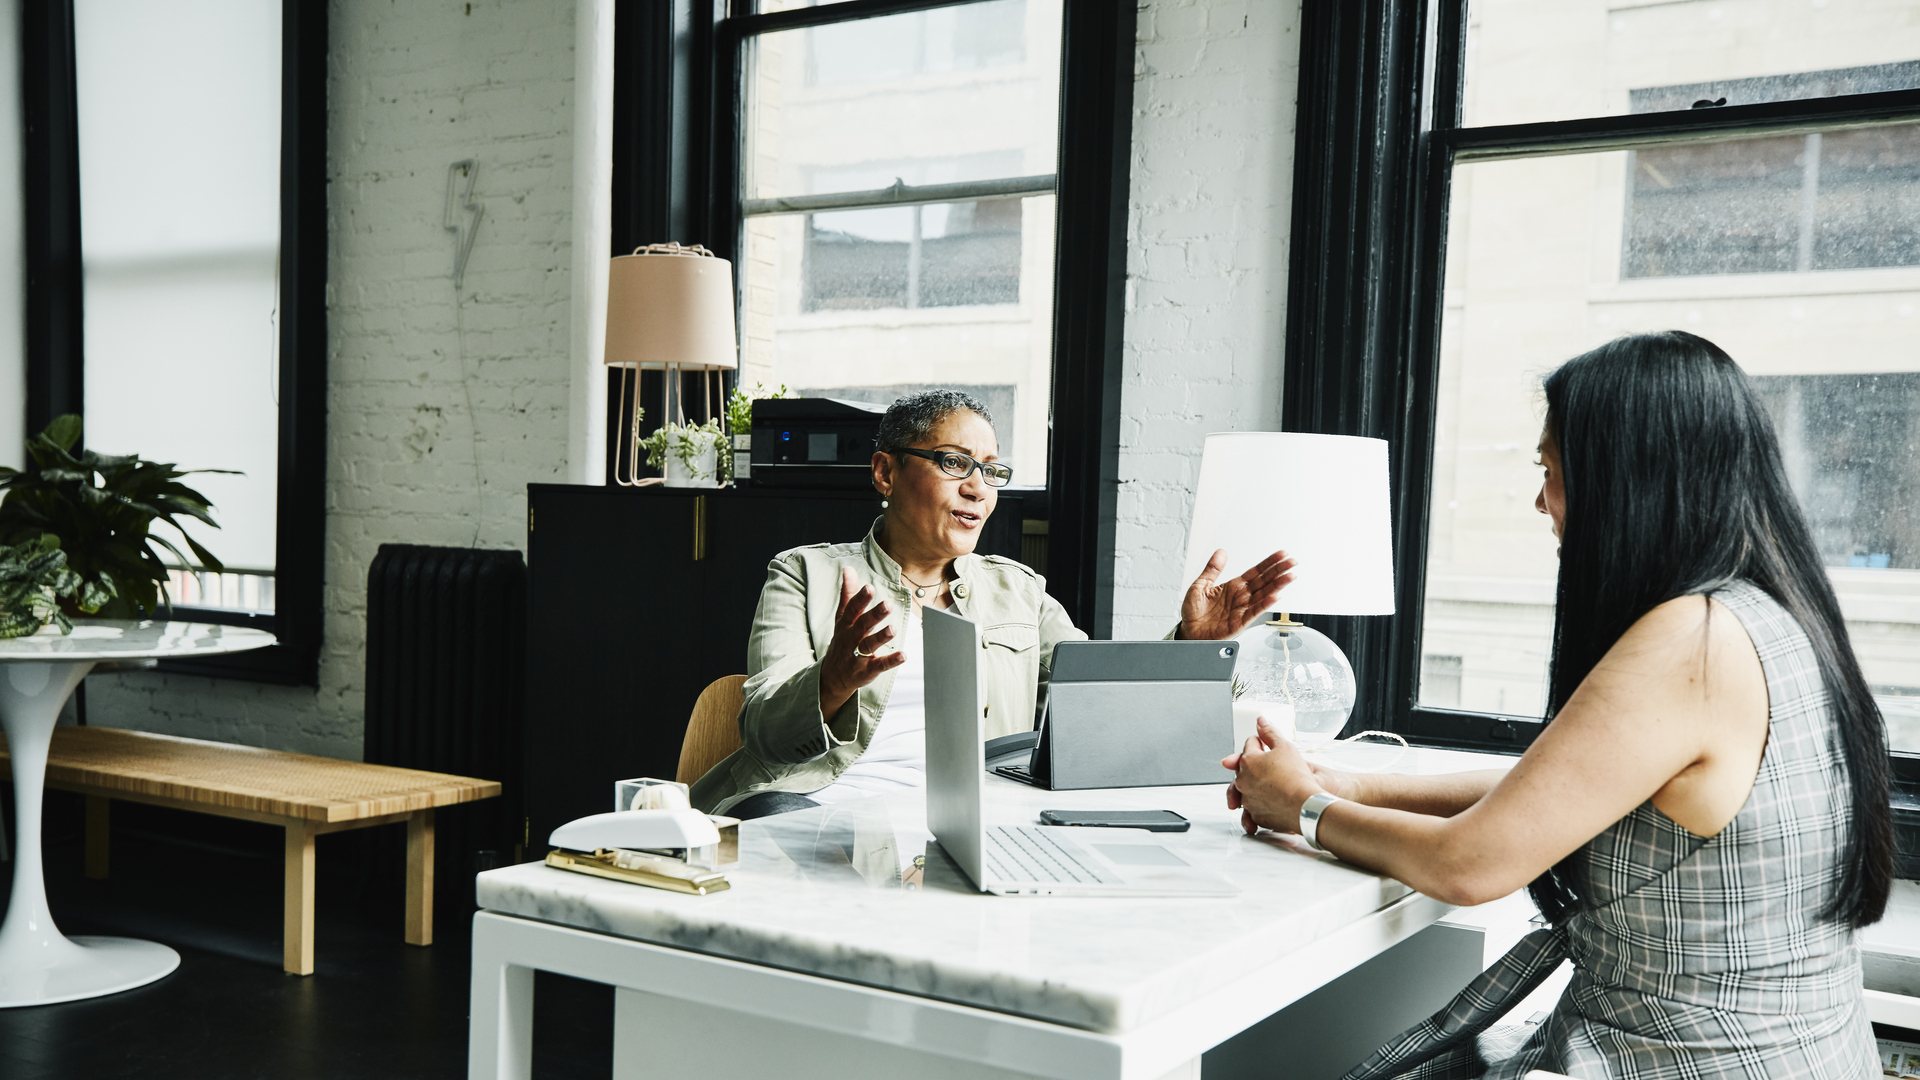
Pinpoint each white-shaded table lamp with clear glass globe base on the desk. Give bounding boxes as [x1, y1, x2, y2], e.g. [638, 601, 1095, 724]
[1181, 432, 1394, 748]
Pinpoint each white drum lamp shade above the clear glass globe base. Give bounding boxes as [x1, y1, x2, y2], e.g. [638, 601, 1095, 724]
[1181, 432, 1394, 615]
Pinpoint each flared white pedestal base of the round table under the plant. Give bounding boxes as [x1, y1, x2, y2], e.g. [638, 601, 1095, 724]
[0, 661, 180, 1009]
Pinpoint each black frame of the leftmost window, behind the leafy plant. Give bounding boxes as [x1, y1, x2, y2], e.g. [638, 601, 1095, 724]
[21, 0, 326, 686]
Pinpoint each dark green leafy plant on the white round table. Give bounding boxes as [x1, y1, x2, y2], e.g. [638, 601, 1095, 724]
[0, 415, 230, 619]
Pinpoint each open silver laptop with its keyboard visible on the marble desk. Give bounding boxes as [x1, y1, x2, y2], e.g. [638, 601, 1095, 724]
[922, 607, 1240, 896]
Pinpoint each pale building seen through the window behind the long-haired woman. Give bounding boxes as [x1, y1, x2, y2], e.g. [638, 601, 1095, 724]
[1417, 16, 1920, 751]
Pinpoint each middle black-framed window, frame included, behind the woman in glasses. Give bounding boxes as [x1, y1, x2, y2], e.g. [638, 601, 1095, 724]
[609, 0, 1137, 634]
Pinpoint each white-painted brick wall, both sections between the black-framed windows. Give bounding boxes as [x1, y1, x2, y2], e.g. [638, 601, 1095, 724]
[88, 0, 1298, 757]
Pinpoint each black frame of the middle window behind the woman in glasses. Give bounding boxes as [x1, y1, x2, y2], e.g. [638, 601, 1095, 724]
[607, 0, 1137, 638]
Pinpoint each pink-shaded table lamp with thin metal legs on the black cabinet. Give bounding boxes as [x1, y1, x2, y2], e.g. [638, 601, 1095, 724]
[605, 244, 739, 488]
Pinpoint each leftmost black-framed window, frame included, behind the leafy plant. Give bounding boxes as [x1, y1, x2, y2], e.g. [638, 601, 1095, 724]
[21, 0, 326, 684]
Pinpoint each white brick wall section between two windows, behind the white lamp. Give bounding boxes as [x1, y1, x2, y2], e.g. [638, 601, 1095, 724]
[1114, 0, 1300, 638]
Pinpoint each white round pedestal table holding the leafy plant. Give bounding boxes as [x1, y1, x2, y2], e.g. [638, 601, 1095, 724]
[0, 619, 275, 1009]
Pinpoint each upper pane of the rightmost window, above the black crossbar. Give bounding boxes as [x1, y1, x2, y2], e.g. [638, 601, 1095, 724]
[1463, 0, 1920, 127]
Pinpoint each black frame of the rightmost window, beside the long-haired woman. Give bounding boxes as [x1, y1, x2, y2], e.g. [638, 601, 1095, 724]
[1281, 0, 1920, 753]
